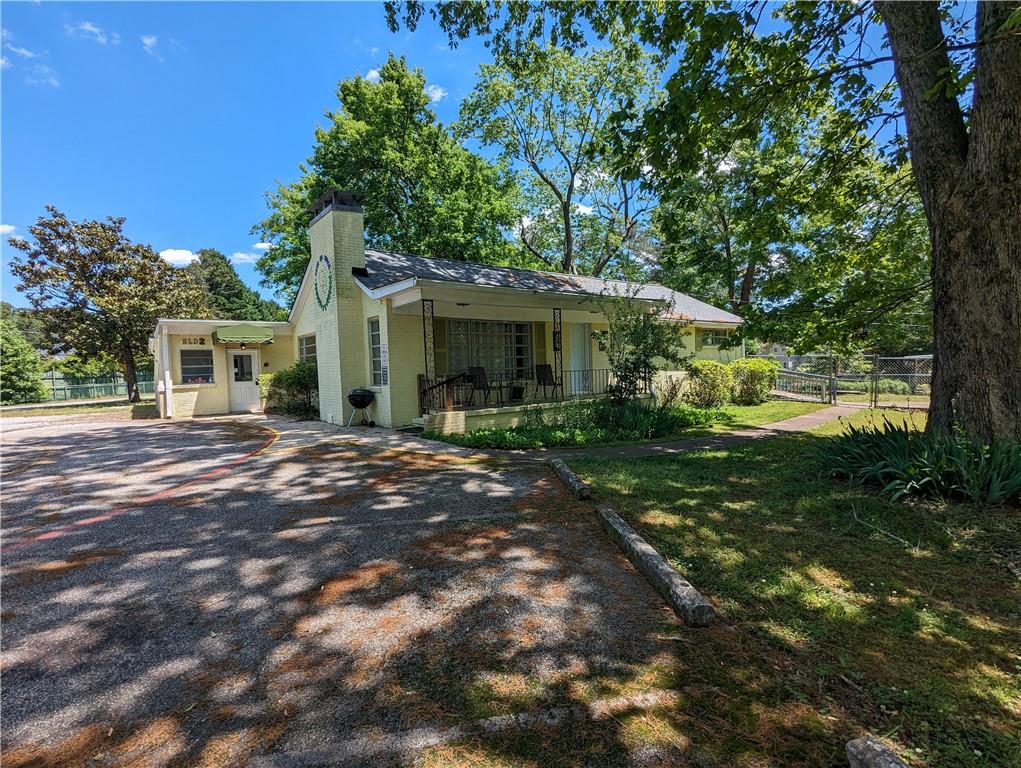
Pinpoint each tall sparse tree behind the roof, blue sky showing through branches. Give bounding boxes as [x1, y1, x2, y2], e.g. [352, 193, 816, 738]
[457, 36, 657, 276]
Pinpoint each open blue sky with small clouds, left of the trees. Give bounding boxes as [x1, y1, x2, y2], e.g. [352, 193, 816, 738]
[0, 2, 489, 305]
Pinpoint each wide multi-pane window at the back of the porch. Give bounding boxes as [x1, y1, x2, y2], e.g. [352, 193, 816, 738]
[447, 320, 534, 379]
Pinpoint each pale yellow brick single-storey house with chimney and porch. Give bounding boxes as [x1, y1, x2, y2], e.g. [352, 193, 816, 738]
[152, 192, 741, 431]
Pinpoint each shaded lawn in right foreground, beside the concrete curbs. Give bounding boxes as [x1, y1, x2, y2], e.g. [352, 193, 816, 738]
[571, 404, 1021, 768]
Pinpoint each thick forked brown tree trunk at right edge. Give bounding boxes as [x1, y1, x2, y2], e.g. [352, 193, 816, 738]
[876, 2, 1021, 440]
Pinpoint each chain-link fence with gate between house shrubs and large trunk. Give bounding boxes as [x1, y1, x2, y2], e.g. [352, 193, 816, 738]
[749, 354, 932, 409]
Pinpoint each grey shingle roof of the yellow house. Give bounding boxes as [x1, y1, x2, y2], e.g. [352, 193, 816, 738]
[358, 248, 742, 323]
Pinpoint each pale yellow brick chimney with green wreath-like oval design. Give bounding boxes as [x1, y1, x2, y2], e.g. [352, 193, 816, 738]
[308, 190, 367, 424]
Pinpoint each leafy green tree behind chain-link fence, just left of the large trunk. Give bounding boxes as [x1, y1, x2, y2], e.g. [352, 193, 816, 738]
[657, 124, 932, 353]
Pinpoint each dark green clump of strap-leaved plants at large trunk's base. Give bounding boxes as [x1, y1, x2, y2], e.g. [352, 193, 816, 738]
[822, 418, 1021, 507]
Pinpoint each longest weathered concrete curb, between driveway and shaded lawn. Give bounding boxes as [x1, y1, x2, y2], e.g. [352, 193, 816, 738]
[596, 507, 716, 627]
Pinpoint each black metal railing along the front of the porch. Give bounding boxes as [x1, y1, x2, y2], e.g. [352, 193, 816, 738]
[419, 368, 614, 414]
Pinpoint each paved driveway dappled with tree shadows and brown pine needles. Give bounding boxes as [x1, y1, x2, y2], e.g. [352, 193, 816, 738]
[2, 417, 679, 768]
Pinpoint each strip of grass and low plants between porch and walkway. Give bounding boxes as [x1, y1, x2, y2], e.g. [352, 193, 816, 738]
[426, 400, 826, 448]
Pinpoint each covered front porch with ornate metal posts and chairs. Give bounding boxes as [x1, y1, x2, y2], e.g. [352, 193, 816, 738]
[379, 280, 653, 432]
